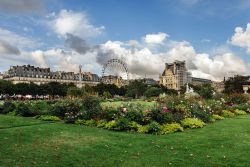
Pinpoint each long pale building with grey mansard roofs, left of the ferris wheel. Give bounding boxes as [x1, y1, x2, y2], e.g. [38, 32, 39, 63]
[3, 65, 100, 86]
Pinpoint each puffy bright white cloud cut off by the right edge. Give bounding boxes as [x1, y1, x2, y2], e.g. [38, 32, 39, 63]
[231, 23, 250, 54]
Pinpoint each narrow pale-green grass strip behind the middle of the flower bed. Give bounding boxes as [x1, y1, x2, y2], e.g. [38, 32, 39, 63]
[101, 100, 157, 110]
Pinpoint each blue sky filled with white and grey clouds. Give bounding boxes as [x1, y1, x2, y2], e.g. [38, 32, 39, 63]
[0, 0, 250, 81]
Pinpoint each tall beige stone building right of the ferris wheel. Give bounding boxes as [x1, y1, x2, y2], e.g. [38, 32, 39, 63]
[160, 61, 192, 90]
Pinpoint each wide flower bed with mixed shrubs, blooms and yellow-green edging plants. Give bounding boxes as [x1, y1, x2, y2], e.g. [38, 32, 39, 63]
[0, 95, 250, 134]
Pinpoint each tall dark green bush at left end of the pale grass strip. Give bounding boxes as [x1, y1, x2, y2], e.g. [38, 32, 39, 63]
[83, 96, 102, 120]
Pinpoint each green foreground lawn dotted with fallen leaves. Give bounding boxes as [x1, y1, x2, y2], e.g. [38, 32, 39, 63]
[0, 115, 250, 167]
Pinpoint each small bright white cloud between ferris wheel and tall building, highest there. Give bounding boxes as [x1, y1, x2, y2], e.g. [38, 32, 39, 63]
[143, 32, 168, 44]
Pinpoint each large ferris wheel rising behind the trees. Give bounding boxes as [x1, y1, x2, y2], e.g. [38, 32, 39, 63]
[102, 59, 129, 80]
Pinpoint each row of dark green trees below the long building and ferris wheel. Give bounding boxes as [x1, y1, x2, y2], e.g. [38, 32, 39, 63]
[0, 80, 180, 98]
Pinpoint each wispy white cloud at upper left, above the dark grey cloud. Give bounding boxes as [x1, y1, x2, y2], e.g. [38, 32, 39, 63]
[47, 9, 105, 38]
